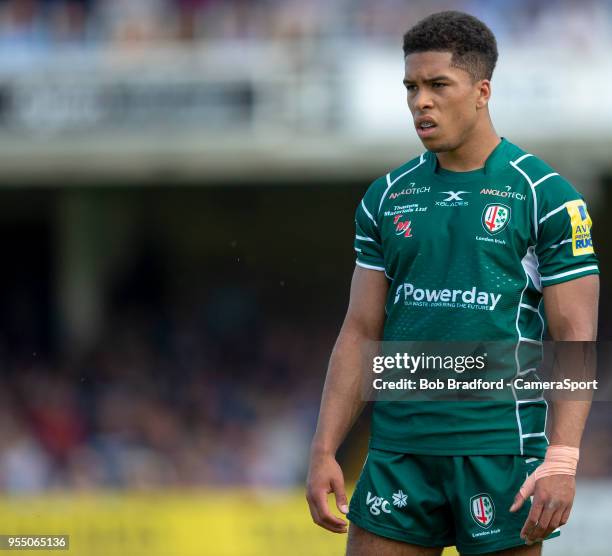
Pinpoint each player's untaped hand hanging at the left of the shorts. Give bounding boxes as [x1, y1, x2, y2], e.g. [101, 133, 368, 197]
[306, 454, 348, 533]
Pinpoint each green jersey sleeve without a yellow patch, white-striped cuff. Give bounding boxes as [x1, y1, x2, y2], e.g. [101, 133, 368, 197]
[355, 180, 385, 272]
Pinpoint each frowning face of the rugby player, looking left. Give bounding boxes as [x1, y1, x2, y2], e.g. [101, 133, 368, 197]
[404, 52, 488, 152]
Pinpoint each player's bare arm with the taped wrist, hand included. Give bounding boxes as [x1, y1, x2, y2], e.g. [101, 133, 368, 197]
[510, 275, 599, 544]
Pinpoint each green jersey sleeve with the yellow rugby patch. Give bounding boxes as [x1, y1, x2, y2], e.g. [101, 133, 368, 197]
[536, 176, 599, 286]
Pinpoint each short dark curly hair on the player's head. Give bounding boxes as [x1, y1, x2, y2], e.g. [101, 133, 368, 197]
[404, 11, 497, 80]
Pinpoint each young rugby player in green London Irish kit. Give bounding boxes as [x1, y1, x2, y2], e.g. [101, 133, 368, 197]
[307, 12, 599, 556]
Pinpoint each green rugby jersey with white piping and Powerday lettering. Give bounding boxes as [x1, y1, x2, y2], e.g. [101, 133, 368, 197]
[355, 139, 599, 457]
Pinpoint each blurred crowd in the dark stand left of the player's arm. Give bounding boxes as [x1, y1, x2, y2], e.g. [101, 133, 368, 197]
[0, 300, 334, 492]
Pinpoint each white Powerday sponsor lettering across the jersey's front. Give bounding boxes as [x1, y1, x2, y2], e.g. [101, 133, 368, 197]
[393, 282, 501, 311]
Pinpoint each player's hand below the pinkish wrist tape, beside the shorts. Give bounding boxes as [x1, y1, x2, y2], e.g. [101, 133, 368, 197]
[510, 475, 576, 544]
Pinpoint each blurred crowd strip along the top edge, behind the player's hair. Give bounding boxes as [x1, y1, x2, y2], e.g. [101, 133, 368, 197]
[0, 0, 612, 51]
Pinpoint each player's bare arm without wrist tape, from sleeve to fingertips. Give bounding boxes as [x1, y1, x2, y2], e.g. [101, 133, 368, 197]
[306, 266, 389, 533]
